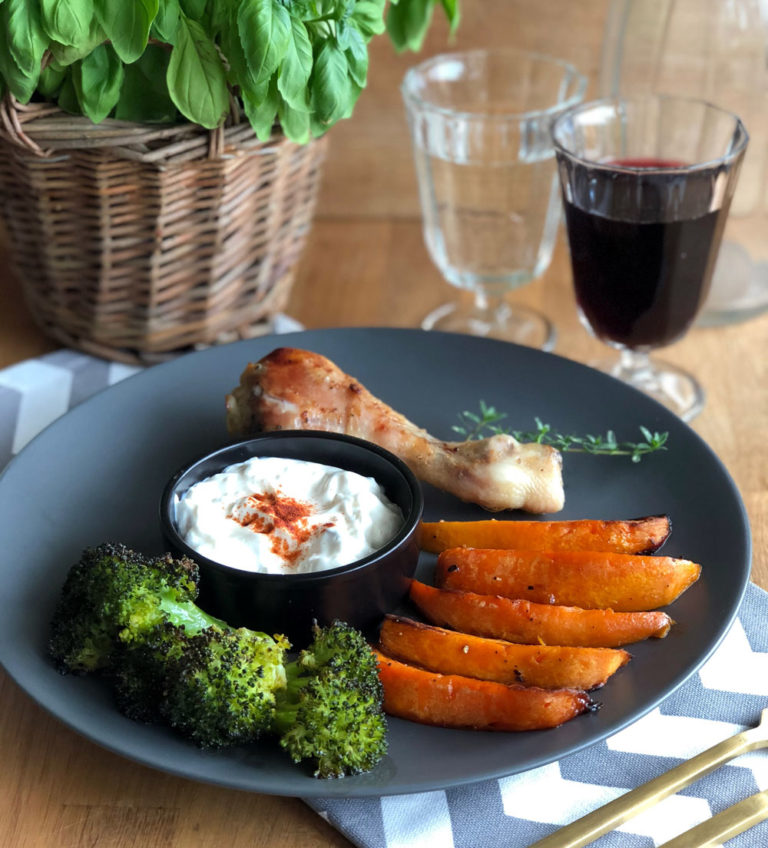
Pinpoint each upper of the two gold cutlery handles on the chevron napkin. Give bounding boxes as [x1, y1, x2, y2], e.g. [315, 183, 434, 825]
[529, 710, 768, 848]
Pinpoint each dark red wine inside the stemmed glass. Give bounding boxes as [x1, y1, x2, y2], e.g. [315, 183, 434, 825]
[565, 160, 727, 349]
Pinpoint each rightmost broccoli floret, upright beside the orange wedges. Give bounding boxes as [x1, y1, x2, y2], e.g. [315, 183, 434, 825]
[273, 621, 387, 778]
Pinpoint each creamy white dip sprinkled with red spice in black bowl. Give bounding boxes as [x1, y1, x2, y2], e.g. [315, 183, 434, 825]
[176, 457, 403, 574]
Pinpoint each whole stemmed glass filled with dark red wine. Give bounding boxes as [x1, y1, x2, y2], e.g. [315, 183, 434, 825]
[552, 95, 749, 420]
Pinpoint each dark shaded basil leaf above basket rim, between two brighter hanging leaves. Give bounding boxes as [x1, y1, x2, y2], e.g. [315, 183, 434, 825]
[115, 44, 178, 124]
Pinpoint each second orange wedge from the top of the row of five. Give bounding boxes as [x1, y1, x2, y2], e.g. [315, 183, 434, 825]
[435, 548, 701, 612]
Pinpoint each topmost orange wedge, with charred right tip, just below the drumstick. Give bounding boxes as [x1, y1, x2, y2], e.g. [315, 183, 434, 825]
[419, 515, 672, 554]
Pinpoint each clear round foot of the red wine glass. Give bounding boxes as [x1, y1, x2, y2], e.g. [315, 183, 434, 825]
[589, 358, 706, 421]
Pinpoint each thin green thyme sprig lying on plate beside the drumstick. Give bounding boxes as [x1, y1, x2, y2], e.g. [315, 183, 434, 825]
[452, 400, 669, 462]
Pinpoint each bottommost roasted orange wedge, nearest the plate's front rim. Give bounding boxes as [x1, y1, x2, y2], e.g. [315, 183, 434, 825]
[377, 652, 593, 731]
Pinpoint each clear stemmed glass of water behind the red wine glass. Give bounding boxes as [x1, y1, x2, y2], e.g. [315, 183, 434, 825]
[402, 49, 586, 349]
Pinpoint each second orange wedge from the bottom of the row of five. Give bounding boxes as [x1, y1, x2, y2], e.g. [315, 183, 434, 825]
[379, 615, 630, 690]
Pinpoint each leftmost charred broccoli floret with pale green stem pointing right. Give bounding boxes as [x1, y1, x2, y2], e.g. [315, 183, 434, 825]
[49, 544, 222, 674]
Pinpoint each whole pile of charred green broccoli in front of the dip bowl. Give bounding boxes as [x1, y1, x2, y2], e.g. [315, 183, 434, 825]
[49, 544, 386, 777]
